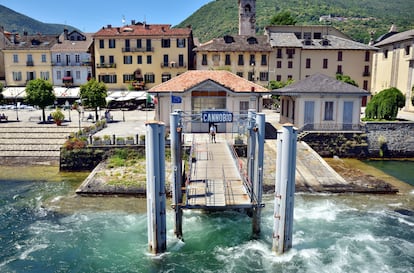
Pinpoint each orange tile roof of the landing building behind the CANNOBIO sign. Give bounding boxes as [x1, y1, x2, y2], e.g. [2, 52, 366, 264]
[149, 70, 269, 93]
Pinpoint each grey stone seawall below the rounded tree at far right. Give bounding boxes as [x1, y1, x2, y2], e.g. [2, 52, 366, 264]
[365, 122, 414, 158]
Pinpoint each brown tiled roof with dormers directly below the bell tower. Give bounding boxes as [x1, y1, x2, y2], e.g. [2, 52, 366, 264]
[194, 35, 272, 52]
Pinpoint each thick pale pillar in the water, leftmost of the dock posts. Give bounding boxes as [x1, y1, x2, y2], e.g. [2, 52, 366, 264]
[145, 121, 167, 254]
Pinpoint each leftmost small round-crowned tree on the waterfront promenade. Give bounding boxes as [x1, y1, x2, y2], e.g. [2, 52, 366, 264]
[26, 79, 56, 122]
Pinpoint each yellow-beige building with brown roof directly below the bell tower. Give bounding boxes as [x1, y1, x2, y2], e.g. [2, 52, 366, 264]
[194, 35, 272, 86]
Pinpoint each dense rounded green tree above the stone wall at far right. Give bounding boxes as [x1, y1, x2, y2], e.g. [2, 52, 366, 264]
[365, 87, 405, 120]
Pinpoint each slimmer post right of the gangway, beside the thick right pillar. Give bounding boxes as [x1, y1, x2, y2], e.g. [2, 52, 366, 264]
[253, 113, 266, 237]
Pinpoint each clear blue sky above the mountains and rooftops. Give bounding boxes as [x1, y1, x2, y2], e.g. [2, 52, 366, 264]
[0, 0, 212, 32]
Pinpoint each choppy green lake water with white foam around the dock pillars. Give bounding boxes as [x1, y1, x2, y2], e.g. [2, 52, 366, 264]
[0, 163, 414, 273]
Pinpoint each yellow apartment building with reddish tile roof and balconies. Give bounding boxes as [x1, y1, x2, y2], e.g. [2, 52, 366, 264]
[93, 21, 194, 90]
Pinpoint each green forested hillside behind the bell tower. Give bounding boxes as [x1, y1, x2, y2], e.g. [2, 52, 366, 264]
[178, 0, 414, 43]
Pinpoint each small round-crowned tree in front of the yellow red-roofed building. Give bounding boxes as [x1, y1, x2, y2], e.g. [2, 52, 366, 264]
[80, 79, 107, 120]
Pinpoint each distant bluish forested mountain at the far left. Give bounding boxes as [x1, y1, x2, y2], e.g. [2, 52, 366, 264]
[0, 5, 74, 34]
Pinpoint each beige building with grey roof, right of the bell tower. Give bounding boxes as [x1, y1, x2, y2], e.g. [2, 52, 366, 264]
[265, 26, 377, 91]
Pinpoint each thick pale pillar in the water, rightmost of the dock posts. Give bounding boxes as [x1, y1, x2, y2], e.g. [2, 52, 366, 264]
[273, 125, 297, 254]
